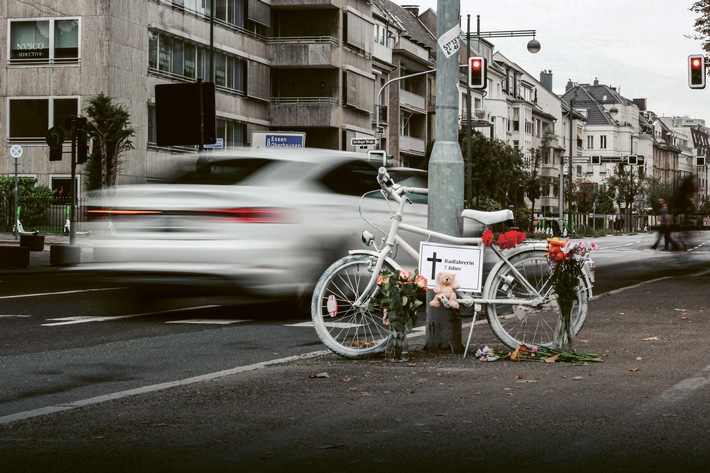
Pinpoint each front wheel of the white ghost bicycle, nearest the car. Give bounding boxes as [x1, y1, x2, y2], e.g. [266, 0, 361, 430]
[311, 255, 394, 358]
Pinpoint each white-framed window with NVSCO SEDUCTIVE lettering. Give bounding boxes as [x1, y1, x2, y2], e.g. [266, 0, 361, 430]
[8, 18, 80, 65]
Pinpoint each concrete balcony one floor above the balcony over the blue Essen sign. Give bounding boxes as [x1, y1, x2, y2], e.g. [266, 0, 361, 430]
[268, 36, 342, 67]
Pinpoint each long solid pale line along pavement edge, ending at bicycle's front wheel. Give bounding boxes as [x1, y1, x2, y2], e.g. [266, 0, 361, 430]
[0, 350, 331, 425]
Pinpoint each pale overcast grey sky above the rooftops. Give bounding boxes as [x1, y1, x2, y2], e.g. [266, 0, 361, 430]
[393, 0, 710, 120]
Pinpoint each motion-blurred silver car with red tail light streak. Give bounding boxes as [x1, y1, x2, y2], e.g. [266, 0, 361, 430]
[83, 149, 427, 299]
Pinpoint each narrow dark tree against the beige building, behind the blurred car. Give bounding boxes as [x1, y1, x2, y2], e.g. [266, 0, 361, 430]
[85, 93, 135, 190]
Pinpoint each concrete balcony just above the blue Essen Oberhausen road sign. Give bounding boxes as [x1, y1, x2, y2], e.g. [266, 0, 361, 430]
[269, 97, 341, 127]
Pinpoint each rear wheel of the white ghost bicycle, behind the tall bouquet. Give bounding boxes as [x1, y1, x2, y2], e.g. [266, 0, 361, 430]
[484, 250, 590, 349]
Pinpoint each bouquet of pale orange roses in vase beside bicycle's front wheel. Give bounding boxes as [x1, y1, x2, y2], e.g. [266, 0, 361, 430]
[368, 269, 428, 361]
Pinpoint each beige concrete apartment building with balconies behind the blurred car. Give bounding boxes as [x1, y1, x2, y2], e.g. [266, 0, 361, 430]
[0, 0, 384, 192]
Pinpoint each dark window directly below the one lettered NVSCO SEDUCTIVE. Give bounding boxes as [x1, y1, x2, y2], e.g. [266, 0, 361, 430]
[8, 97, 79, 143]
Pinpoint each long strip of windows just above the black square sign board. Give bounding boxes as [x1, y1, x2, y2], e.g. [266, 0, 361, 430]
[148, 31, 247, 94]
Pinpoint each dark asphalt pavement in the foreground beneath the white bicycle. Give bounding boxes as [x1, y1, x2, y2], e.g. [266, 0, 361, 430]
[0, 271, 710, 472]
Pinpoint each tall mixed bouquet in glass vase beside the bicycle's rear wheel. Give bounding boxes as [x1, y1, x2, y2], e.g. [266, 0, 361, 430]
[547, 238, 597, 349]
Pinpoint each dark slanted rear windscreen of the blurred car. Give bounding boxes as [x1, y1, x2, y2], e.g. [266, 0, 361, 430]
[172, 158, 274, 186]
